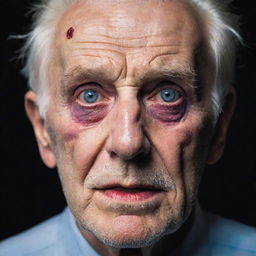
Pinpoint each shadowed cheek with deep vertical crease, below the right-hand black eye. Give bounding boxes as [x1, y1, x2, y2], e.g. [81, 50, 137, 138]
[151, 116, 204, 184]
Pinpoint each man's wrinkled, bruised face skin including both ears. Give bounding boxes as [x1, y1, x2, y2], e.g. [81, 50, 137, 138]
[25, 0, 235, 255]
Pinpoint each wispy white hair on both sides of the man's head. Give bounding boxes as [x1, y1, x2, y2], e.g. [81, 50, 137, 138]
[21, 0, 241, 120]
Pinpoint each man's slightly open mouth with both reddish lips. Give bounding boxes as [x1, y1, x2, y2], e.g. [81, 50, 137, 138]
[95, 185, 164, 203]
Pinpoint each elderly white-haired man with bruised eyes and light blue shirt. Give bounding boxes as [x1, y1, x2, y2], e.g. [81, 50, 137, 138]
[0, 0, 256, 256]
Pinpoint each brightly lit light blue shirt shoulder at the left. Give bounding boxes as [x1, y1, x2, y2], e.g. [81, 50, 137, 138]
[0, 211, 67, 256]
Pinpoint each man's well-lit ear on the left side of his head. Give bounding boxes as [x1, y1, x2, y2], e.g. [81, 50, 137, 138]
[25, 91, 56, 168]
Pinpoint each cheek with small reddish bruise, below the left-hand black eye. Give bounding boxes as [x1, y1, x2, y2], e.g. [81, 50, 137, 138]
[50, 116, 101, 179]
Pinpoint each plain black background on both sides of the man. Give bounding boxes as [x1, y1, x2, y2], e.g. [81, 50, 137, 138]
[0, 0, 256, 239]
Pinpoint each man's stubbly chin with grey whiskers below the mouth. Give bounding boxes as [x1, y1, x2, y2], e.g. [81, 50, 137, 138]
[77, 206, 185, 248]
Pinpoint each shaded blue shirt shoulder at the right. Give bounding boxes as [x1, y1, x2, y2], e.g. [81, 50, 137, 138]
[206, 213, 256, 256]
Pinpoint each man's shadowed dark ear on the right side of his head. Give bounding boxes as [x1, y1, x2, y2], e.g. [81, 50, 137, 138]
[206, 87, 236, 164]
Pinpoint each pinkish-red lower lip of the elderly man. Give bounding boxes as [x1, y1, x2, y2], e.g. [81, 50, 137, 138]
[102, 189, 161, 202]
